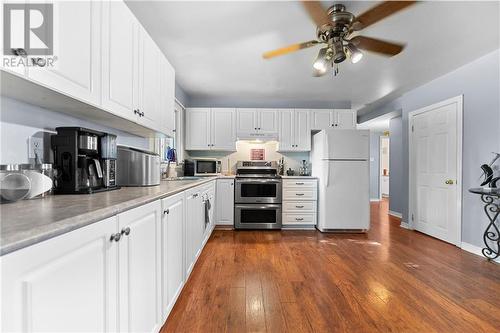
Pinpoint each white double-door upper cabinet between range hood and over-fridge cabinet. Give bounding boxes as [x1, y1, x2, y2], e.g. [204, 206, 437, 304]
[279, 109, 311, 152]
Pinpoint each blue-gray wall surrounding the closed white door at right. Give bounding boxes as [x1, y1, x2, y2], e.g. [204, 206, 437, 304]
[362, 50, 500, 246]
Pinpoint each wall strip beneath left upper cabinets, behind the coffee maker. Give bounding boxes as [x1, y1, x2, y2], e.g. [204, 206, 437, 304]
[0, 96, 149, 164]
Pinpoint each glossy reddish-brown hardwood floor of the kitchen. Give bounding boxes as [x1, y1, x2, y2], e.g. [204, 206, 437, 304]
[162, 201, 500, 333]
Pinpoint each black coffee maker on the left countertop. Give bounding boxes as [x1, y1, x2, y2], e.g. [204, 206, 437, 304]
[52, 127, 119, 194]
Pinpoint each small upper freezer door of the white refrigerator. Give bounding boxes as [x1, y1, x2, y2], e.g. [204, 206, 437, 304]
[323, 129, 370, 160]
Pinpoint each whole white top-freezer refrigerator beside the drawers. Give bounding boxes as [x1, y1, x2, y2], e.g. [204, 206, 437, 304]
[311, 129, 370, 232]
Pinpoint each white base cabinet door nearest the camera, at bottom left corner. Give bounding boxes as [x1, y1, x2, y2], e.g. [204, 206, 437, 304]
[1, 217, 119, 332]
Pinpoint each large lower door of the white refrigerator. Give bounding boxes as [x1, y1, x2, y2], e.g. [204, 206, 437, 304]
[318, 161, 370, 231]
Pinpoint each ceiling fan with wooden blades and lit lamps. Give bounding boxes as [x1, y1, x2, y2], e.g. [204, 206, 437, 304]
[262, 0, 417, 76]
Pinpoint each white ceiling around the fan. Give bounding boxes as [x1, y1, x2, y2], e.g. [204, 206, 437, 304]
[127, 1, 500, 113]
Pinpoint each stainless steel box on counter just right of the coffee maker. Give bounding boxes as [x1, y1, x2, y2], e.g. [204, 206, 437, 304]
[116, 146, 160, 186]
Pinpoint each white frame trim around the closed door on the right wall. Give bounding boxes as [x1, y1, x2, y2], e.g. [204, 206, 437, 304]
[408, 95, 463, 247]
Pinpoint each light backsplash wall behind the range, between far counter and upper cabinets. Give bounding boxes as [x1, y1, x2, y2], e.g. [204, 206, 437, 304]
[186, 141, 310, 173]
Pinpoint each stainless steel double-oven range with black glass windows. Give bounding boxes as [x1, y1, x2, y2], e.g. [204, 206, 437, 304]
[234, 161, 281, 229]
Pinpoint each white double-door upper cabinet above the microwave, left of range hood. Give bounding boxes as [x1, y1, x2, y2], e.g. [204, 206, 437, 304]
[186, 108, 236, 151]
